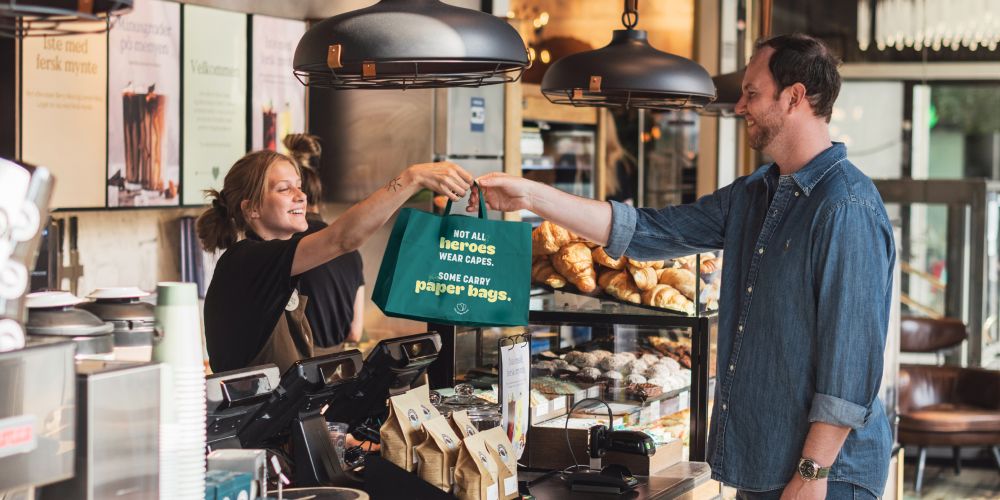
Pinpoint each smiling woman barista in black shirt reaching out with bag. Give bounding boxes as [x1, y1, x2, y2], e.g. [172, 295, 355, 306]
[197, 151, 472, 372]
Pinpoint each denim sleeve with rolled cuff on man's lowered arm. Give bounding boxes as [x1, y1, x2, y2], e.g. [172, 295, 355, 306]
[809, 200, 895, 429]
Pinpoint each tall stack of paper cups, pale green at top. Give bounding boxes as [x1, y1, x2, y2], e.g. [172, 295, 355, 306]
[153, 283, 205, 500]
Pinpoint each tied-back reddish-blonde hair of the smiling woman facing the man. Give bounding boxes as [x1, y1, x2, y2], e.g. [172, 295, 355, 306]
[195, 150, 298, 252]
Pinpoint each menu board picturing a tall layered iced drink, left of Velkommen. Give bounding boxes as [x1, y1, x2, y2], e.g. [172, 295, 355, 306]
[107, 0, 181, 207]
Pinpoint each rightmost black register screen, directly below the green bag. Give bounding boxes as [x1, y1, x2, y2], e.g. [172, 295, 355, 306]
[326, 333, 441, 434]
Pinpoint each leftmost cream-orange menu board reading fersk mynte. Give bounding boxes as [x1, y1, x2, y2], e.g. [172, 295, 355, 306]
[21, 23, 108, 208]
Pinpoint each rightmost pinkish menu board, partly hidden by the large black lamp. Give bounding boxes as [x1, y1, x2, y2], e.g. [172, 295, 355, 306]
[250, 16, 306, 153]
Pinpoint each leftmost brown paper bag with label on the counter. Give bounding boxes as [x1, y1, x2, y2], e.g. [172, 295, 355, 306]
[379, 393, 440, 472]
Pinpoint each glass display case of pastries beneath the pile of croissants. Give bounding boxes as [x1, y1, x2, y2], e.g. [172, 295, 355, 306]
[429, 288, 718, 466]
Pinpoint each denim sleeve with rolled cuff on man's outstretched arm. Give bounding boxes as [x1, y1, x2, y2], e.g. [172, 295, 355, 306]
[605, 185, 732, 260]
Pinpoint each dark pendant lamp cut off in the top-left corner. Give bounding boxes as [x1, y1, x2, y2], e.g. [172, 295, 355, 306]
[0, 0, 133, 38]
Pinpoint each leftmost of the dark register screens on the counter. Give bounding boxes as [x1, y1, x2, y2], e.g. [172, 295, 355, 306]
[205, 365, 281, 451]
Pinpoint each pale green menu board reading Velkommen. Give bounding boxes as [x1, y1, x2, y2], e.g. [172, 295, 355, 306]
[181, 5, 247, 205]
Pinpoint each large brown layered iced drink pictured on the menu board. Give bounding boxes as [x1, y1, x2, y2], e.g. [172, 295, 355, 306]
[122, 85, 167, 191]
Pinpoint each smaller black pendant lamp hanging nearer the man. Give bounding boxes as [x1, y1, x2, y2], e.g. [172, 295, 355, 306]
[542, 0, 715, 110]
